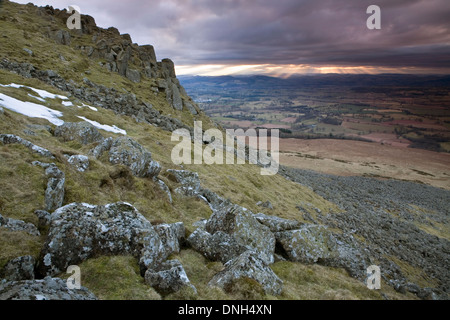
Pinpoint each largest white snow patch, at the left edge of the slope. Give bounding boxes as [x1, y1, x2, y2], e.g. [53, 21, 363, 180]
[0, 93, 64, 126]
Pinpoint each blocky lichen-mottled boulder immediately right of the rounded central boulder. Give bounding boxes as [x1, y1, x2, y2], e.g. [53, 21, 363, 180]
[275, 224, 333, 263]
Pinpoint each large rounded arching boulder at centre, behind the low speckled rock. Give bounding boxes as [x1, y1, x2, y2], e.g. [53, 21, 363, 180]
[206, 205, 275, 264]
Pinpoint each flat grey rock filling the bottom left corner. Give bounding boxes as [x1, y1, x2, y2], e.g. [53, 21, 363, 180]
[0, 277, 97, 300]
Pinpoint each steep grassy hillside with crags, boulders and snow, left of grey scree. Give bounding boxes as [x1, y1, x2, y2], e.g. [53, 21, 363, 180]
[0, 1, 446, 299]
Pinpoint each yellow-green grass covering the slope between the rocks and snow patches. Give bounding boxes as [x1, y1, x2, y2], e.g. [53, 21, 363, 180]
[0, 1, 424, 299]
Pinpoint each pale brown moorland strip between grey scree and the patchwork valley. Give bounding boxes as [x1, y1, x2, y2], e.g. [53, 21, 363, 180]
[280, 139, 450, 190]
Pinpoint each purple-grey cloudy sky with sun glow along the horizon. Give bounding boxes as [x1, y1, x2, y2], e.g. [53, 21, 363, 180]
[15, 0, 450, 76]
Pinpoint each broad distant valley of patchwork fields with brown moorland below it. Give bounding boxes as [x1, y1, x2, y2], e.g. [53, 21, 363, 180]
[183, 75, 450, 189]
